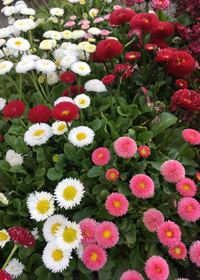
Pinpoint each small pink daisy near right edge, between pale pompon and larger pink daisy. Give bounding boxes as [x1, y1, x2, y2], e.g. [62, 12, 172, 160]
[176, 178, 197, 196]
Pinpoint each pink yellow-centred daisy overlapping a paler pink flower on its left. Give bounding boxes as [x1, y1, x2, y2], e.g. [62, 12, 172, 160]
[96, 221, 119, 248]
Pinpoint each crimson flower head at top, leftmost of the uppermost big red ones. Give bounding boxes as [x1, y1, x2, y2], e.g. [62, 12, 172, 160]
[109, 9, 136, 26]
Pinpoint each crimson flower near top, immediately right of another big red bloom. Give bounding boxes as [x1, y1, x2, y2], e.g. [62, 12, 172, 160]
[130, 13, 159, 33]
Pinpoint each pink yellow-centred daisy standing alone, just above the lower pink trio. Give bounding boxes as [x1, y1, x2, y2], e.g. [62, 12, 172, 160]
[105, 193, 129, 217]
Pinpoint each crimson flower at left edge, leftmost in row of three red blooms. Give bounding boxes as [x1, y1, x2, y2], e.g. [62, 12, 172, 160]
[3, 100, 26, 118]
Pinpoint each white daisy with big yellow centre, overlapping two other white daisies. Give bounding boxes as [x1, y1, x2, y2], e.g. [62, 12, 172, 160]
[55, 221, 82, 250]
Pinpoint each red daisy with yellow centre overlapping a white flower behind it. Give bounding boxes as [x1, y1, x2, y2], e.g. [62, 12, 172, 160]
[51, 102, 79, 122]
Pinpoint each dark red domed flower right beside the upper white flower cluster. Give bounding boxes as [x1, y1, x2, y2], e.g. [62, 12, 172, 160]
[96, 39, 123, 61]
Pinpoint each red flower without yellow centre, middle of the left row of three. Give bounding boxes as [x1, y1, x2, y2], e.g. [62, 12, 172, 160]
[27, 105, 51, 123]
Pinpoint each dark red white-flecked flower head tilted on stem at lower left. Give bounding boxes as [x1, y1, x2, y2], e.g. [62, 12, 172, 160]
[8, 227, 35, 247]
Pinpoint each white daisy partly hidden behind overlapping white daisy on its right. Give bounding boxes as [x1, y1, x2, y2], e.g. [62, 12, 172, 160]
[42, 215, 68, 242]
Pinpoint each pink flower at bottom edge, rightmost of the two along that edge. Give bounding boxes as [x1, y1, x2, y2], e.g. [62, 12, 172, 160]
[144, 256, 169, 280]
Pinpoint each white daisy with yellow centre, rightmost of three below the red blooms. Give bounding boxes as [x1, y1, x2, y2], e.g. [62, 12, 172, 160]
[68, 126, 95, 147]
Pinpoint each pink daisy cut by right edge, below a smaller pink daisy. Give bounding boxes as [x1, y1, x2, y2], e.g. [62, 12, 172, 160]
[178, 197, 200, 222]
